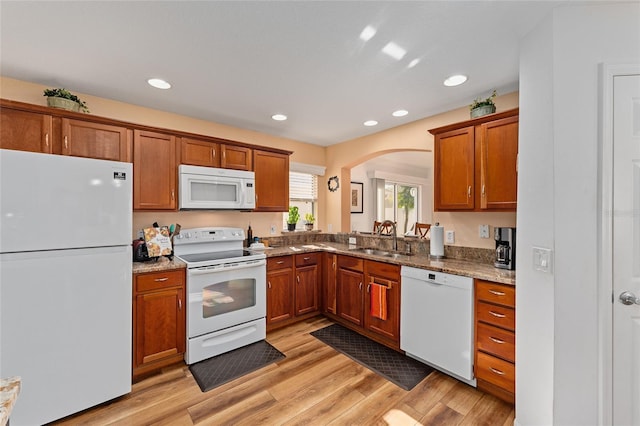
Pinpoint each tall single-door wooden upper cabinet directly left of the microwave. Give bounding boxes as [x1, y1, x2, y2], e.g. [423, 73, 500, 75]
[133, 130, 178, 210]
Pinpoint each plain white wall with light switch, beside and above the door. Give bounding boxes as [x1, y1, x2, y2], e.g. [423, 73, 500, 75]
[516, 2, 640, 425]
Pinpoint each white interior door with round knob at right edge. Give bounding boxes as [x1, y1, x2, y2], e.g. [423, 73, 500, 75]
[613, 71, 640, 426]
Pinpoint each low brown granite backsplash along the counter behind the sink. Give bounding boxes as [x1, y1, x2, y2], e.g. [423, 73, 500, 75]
[263, 231, 495, 265]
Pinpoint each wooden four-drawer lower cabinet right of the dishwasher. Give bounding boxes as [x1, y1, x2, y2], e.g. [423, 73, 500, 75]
[474, 280, 516, 404]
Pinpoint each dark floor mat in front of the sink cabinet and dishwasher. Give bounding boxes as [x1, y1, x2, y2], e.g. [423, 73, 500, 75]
[311, 324, 433, 390]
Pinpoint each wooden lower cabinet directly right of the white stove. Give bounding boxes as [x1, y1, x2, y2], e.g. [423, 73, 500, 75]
[267, 253, 322, 330]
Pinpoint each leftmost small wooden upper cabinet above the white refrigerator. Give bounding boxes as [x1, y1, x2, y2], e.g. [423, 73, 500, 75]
[0, 107, 53, 154]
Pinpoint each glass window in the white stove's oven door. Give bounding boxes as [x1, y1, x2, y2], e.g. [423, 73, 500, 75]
[202, 278, 256, 318]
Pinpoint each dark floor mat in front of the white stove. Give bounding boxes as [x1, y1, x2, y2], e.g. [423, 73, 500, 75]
[189, 340, 285, 392]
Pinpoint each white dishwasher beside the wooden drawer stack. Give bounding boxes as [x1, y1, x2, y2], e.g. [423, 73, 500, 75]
[400, 266, 476, 386]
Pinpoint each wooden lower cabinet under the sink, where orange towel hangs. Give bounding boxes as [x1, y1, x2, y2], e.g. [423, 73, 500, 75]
[336, 255, 400, 351]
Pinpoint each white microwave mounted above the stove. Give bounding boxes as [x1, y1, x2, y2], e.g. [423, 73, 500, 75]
[178, 164, 256, 210]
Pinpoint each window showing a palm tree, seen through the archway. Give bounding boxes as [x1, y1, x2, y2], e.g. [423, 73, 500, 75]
[384, 181, 419, 235]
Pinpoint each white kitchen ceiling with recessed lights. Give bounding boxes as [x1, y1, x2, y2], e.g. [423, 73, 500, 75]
[0, 0, 575, 146]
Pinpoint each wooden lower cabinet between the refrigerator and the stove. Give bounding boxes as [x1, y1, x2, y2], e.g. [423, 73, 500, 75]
[133, 269, 186, 380]
